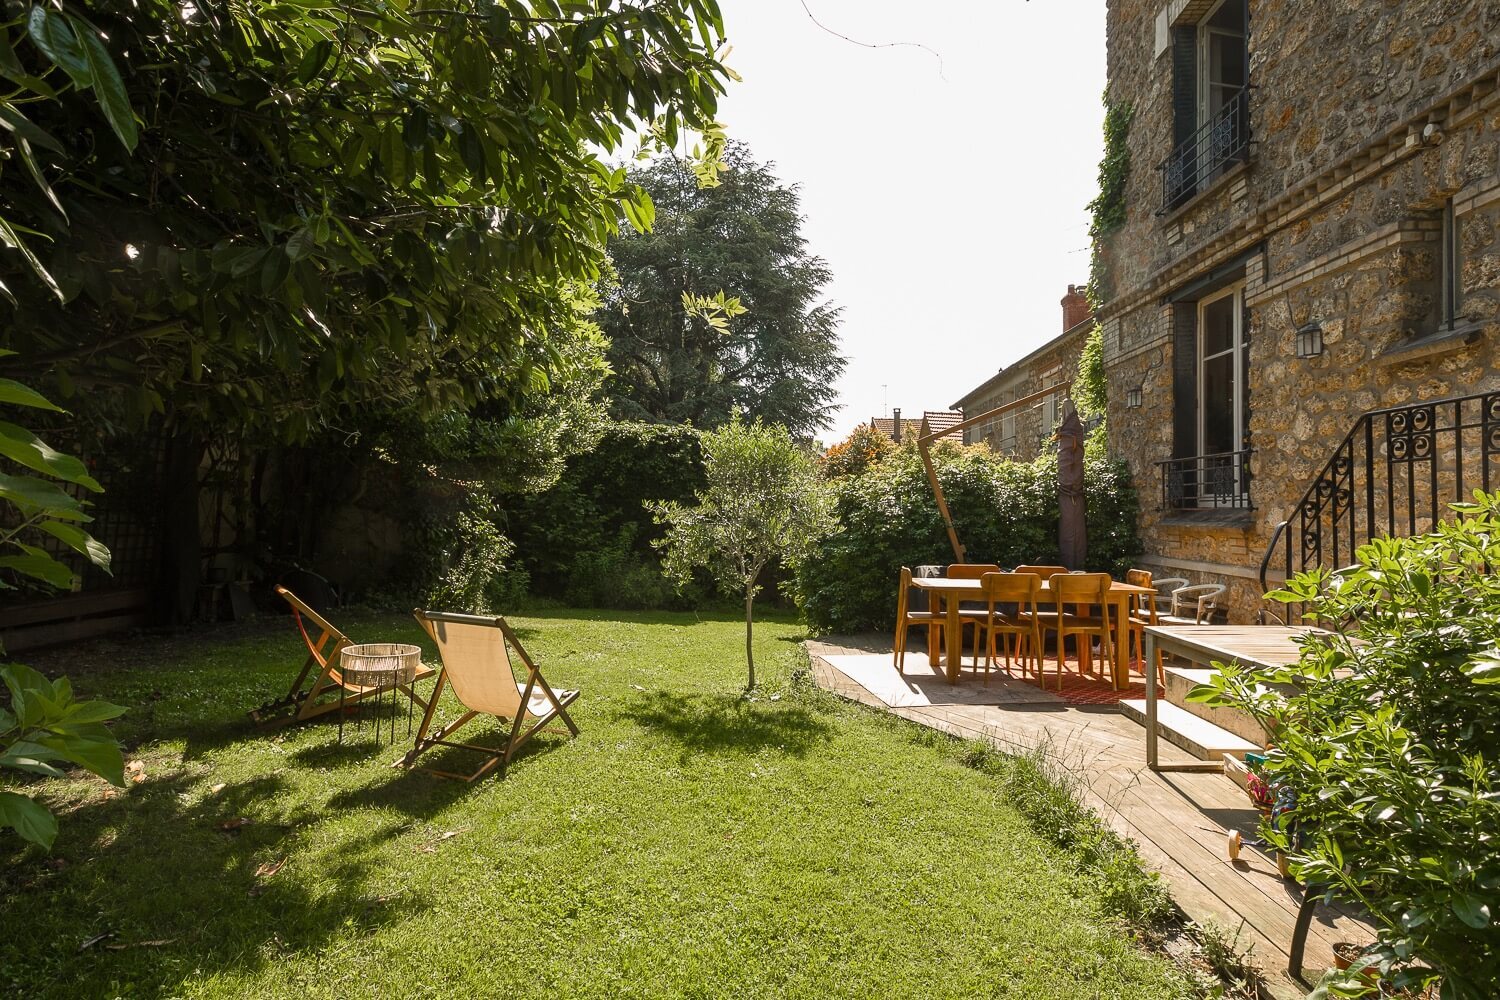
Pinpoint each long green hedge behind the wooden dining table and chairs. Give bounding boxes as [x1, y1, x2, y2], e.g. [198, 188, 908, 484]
[795, 444, 1140, 631]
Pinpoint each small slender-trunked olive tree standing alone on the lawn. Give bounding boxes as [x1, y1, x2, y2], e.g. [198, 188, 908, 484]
[651, 420, 833, 691]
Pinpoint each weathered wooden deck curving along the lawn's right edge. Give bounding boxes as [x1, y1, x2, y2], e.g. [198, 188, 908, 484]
[807, 636, 1371, 1000]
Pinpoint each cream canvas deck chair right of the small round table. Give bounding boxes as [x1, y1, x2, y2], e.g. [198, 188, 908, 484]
[396, 610, 578, 781]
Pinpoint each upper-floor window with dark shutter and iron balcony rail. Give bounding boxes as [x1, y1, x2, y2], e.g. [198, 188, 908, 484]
[1161, 0, 1250, 211]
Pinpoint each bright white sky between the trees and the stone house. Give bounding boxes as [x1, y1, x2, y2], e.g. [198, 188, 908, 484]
[719, 0, 1104, 442]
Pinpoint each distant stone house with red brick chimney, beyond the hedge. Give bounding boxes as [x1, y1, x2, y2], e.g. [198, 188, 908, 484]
[953, 285, 1094, 462]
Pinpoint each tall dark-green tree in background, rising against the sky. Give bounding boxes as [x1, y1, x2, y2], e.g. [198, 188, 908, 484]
[600, 142, 845, 435]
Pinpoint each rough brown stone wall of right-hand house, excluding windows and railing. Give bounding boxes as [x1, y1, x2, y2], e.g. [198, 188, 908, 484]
[1101, 0, 1500, 621]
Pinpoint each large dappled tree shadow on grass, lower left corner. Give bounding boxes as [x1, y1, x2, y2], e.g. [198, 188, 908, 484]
[0, 772, 425, 997]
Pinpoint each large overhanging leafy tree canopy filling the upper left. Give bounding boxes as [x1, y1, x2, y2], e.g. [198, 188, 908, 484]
[0, 0, 728, 439]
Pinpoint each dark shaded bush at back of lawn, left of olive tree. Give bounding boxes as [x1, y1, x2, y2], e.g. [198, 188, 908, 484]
[504, 423, 704, 609]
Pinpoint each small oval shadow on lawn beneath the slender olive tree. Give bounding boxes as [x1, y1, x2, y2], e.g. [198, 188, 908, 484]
[617, 691, 833, 757]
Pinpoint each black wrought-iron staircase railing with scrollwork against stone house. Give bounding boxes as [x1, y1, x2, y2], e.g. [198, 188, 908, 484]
[1260, 393, 1500, 624]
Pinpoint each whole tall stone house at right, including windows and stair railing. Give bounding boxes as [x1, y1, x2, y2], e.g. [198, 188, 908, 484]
[1100, 0, 1500, 621]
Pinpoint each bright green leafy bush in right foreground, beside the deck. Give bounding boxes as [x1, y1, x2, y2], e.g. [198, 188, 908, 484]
[1193, 493, 1500, 1000]
